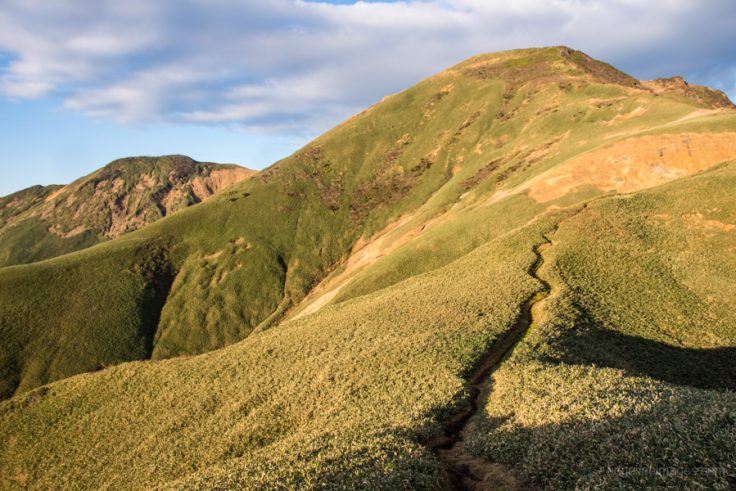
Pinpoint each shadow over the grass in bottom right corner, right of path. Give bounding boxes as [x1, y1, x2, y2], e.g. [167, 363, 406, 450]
[471, 393, 736, 489]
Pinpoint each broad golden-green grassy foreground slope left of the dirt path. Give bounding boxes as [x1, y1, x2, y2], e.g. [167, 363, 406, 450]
[0, 209, 564, 489]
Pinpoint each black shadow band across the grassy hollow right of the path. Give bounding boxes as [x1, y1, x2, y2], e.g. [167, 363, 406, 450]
[547, 328, 736, 390]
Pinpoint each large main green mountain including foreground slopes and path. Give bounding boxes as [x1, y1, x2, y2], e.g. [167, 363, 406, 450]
[0, 47, 736, 489]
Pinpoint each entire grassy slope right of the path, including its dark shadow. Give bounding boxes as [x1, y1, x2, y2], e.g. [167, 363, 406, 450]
[470, 164, 736, 489]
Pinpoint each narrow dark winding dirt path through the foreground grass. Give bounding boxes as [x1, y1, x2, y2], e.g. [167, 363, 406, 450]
[429, 235, 551, 491]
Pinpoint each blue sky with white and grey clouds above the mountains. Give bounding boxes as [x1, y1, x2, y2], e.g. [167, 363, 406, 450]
[0, 0, 736, 196]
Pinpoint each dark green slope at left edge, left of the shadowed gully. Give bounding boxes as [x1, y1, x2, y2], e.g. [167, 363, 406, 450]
[0, 240, 170, 394]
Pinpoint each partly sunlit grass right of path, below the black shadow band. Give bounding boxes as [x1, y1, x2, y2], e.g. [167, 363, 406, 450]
[469, 361, 736, 489]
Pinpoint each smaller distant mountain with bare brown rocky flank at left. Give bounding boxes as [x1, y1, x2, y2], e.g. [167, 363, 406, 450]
[0, 155, 253, 267]
